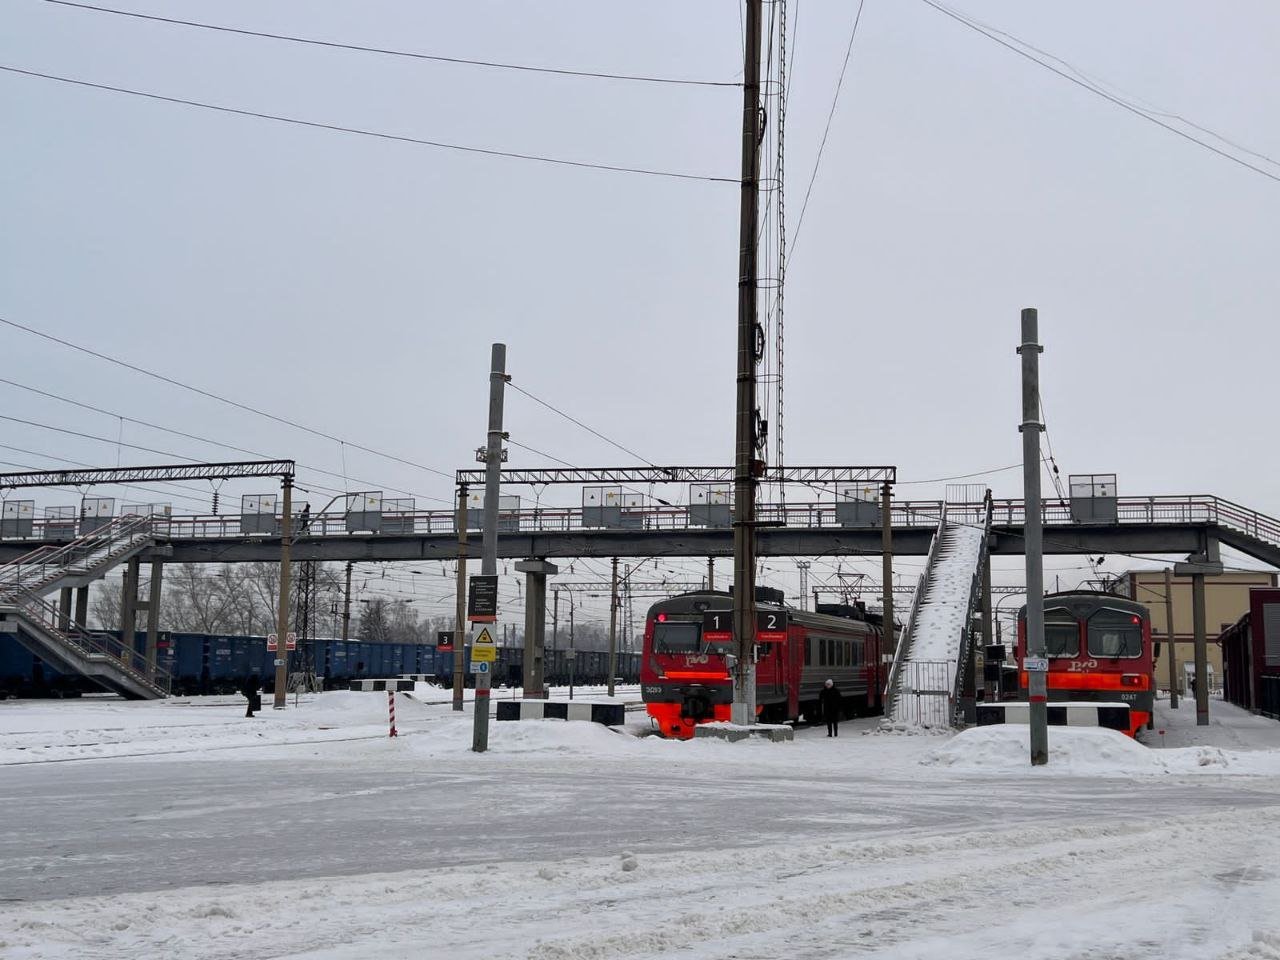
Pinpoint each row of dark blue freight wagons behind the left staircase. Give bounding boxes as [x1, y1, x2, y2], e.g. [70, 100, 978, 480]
[0, 632, 640, 699]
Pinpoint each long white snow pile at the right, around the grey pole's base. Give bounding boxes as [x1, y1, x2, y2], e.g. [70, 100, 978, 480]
[920, 723, 1280, 777]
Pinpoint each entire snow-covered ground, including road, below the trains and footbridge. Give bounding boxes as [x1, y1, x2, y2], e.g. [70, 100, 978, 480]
[0, 689, 1280, 960]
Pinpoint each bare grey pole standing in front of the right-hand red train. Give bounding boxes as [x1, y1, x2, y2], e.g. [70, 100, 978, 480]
[1018, 307, 1048, 767]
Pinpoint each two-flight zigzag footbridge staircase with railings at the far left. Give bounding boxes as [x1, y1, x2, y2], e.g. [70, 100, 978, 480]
[0, 516, 169, 700]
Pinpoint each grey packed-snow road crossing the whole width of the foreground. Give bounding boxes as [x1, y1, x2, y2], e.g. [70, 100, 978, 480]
[0, 744, 1280, 901]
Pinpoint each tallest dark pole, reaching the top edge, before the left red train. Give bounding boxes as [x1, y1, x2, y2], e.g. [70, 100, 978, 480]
[731, 0, 764, 726]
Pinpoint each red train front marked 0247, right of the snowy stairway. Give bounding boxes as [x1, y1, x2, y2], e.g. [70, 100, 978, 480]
[1018, 591, 1156, 736]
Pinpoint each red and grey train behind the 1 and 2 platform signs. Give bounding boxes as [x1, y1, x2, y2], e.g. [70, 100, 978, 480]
[640, 588, 886, 739]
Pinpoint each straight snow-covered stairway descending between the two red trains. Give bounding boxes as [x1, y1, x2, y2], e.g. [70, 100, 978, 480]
[884, 486, 992, 727]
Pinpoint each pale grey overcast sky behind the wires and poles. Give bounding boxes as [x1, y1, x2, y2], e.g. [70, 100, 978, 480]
[0, 0, 1280, 627]
